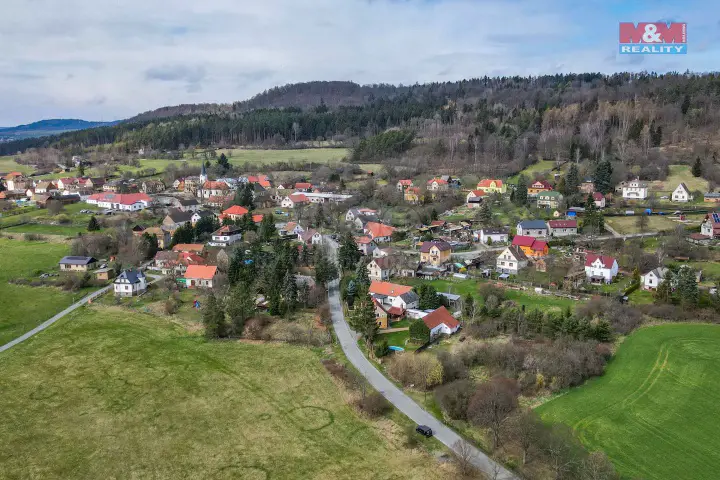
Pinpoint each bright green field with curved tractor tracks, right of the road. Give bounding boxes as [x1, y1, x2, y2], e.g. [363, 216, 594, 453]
[537, 324, 720, 480]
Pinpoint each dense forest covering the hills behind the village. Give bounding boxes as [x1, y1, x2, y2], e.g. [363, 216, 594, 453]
[0, 73, 720, 183]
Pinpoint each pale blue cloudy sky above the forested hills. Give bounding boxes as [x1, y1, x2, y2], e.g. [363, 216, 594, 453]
[0, 0, 720, 126]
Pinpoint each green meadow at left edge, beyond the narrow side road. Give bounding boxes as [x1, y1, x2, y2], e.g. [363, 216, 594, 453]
[0, 238, 86, 345]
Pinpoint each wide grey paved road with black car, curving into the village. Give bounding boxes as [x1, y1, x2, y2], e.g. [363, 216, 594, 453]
[326, 238, 519, 480]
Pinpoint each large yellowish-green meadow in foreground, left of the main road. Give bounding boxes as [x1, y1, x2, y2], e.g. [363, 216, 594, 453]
[0, 306, 443, 479]
